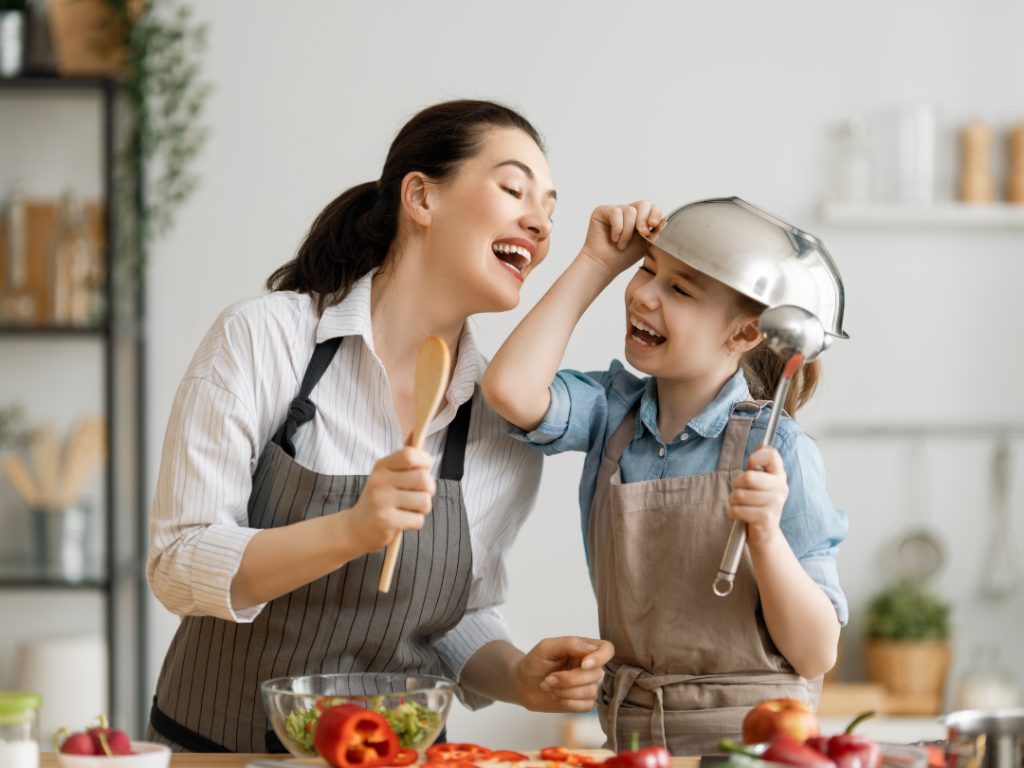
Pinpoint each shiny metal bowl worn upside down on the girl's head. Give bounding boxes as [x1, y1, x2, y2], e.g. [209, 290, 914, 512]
[647, 198, 849, 345]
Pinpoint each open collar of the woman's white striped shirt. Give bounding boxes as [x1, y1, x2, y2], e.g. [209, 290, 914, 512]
[316, 269, 486, 432]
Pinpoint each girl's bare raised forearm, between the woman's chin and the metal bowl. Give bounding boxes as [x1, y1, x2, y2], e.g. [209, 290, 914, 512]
[482, 254, 614, 431]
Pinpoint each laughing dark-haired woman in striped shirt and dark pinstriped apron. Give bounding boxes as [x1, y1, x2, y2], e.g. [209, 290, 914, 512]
[147, 101, 612, 752]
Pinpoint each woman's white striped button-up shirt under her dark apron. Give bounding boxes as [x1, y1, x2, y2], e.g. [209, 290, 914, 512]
[146, 273, 542, 706]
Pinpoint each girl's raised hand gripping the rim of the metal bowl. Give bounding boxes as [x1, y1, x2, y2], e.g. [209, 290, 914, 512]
[581, 200, 664, 278]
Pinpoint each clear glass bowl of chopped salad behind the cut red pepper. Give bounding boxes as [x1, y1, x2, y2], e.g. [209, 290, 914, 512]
[260, 673, 455, 758]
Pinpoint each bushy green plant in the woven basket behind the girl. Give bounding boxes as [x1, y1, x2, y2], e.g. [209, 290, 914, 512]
[867, 583, 949, 640]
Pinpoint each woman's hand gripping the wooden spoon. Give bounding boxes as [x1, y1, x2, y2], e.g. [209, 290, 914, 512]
[337, 446, 437, 554]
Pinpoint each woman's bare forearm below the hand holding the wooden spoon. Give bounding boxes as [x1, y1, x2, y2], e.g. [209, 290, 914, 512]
[231, 510, 366, 610]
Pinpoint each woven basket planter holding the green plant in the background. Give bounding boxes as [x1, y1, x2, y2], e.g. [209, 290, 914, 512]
[867, 640, 952, 715]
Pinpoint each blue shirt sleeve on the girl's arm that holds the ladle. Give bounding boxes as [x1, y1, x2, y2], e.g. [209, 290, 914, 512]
[776, 431, 850, 626]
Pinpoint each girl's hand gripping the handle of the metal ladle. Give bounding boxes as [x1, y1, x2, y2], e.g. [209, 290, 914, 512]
[726, 447, 790, 549]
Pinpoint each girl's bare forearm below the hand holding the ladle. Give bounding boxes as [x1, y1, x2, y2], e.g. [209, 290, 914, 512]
[751, 530, 840, 680]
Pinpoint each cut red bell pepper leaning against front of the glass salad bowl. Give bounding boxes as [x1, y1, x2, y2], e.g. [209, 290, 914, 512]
[313, 705, 398, 768]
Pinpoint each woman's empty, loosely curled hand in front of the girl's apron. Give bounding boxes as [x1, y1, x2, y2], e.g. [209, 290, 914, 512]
[515, 637, 615, 712]
